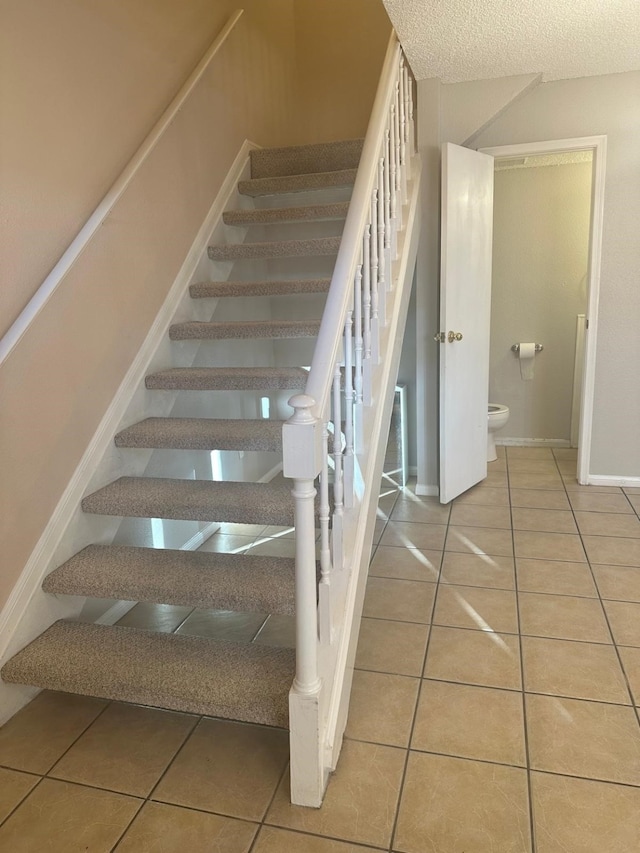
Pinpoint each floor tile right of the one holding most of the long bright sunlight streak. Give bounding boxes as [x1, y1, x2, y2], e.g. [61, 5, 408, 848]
[518, 592, 611, 643]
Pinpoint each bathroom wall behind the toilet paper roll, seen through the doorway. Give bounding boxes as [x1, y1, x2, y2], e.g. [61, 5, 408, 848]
[489, 157, 592, 441]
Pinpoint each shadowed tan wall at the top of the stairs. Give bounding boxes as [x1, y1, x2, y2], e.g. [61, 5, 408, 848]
[296, 0, 391, 142]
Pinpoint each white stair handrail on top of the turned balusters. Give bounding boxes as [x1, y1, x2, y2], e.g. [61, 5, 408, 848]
[304, 30, 402, 418]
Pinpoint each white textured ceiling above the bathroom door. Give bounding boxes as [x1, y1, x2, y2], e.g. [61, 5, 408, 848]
[383, 0, 640, 83]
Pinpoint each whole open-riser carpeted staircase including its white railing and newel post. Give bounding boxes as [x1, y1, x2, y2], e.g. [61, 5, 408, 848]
[1, 36, 420, 806]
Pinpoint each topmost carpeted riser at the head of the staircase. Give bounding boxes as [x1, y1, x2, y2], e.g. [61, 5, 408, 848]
[250, 139, 364, 178]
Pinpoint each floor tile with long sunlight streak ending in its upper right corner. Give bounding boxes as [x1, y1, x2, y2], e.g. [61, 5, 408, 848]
[424, 627, 521, 690]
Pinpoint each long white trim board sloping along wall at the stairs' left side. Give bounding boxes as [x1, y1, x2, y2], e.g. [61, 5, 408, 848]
[0, 140, 258, 660]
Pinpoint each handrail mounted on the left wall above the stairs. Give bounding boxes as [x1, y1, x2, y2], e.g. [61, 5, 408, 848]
[0, 9, 244, 365]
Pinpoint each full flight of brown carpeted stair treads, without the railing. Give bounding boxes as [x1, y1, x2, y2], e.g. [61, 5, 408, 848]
[2, 140, 362, 727]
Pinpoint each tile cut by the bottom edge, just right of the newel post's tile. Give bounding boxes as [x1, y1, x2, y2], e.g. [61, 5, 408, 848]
[393, 752, 531, 853]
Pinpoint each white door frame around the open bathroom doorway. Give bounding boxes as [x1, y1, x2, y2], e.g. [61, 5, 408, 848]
[478, 136, 607, 485]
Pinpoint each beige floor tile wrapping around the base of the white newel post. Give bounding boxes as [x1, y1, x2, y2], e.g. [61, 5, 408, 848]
[265, 740, 405, 849]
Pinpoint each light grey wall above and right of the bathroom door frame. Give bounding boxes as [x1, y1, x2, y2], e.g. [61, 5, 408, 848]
[474, 72, 640, 477]
